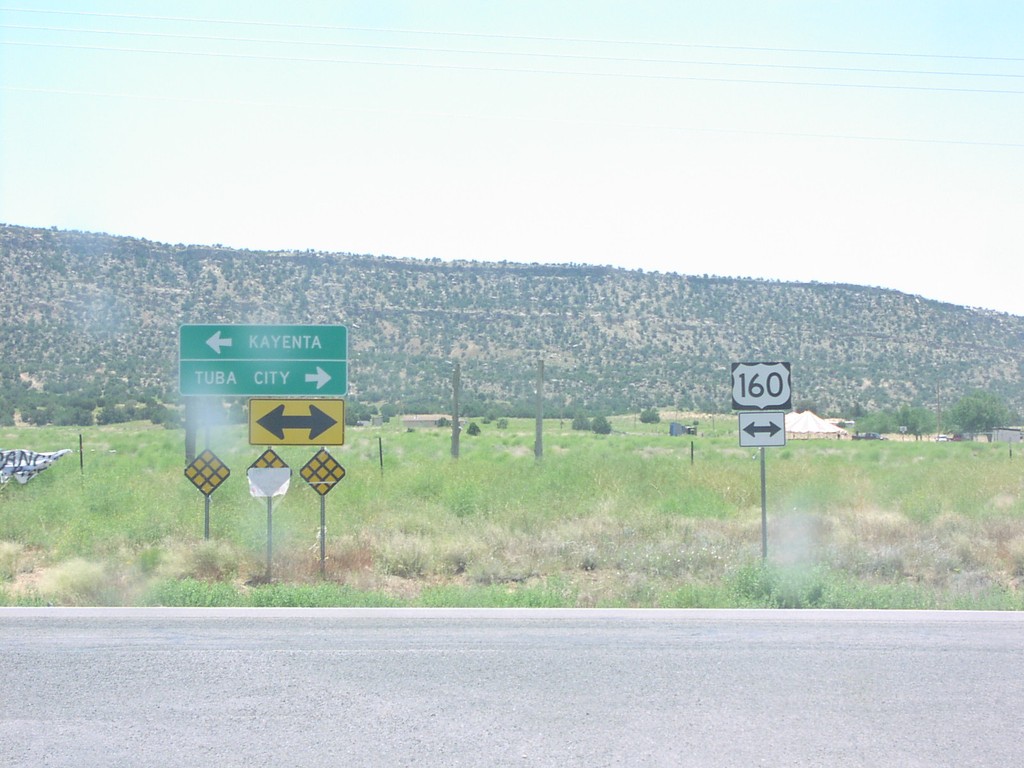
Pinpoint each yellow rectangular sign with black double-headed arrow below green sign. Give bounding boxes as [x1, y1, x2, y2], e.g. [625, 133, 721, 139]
[249, 397, 345, 445]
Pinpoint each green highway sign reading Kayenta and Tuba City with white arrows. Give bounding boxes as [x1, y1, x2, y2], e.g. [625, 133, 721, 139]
[178, 325, 348, 397]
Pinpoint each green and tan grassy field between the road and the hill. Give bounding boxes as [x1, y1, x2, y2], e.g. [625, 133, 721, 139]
[0, 416, 1024, 610]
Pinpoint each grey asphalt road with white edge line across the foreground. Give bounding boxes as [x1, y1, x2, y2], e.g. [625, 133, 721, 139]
[0, 608, 1024, 768]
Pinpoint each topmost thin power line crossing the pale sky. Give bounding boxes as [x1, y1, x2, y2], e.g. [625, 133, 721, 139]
[0, 7, 1024, 61]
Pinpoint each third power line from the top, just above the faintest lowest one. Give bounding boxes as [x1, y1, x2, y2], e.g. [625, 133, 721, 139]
[6, 40, 1024, 96]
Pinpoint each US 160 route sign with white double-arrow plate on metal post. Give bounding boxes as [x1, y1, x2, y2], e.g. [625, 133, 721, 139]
[732, 362, 793, 560]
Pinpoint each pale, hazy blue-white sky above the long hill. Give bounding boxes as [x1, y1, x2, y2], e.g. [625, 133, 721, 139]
[0, 0, 1024, 314]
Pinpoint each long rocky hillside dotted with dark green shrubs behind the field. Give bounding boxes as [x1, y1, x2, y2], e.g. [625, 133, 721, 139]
[0, 225, 1024, 423]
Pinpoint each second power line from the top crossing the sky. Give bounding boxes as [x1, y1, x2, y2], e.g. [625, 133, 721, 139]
[0, 20, 1024, 79]
